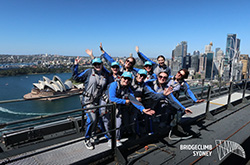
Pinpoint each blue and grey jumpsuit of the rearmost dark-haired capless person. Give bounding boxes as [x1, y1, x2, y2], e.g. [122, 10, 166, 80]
[138, 52, 171, 76]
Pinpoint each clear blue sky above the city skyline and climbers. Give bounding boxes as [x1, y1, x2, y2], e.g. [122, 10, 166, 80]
[0, 0, 250, 58]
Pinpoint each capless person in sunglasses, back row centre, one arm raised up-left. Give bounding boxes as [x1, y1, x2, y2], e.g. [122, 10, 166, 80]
[100, 43, 139, 77]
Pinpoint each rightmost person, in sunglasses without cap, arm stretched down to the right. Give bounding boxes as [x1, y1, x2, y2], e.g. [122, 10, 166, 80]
[167, 69, 205, 103]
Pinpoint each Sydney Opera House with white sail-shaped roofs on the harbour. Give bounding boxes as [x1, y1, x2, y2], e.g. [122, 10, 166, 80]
[23, 76, 84, 100]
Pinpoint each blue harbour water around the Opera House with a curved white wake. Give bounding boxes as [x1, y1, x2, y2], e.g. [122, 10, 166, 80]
[0, 73, 81, 123]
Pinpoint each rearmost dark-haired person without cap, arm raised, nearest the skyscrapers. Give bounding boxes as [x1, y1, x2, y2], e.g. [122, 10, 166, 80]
[135, 46, 171, 76]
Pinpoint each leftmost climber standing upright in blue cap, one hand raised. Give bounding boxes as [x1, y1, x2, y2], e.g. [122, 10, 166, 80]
[72, 57, 109, 149]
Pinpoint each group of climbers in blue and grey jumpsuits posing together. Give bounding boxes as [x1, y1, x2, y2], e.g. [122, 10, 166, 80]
[72, 44, 204, 149]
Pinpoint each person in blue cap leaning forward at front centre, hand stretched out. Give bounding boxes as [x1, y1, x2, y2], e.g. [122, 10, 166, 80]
[108, 72, 155, 146]
